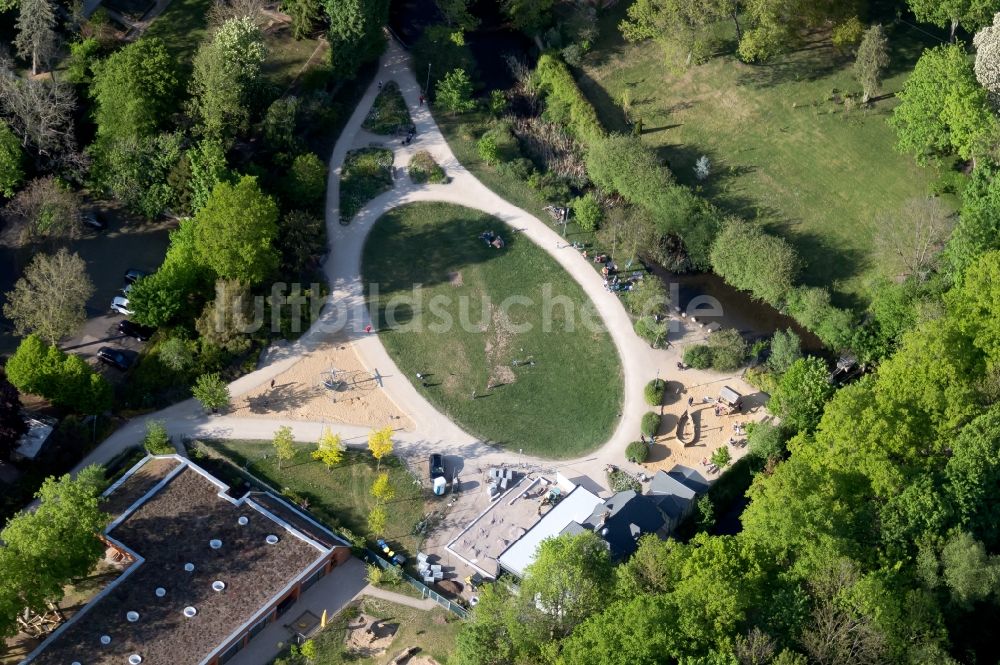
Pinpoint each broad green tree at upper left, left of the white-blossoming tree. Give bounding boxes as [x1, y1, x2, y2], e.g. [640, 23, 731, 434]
[90, 37, 178, 141]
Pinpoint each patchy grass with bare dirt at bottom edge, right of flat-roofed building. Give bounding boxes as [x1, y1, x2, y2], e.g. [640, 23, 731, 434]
[294, 598, 462, 665]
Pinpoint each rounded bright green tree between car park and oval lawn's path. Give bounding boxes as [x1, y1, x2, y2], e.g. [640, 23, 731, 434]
[194, 176, 279, 285]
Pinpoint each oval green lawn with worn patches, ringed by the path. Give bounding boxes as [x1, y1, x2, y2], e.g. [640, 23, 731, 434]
[362, 203, 622, 458]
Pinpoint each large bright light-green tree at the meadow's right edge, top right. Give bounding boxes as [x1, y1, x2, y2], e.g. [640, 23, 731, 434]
[890, 42, 997, 162]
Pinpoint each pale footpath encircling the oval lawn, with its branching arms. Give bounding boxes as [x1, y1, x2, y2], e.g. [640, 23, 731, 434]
[77, 40, 720, 485]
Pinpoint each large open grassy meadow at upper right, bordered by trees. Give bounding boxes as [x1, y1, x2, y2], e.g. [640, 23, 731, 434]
[580, 13, 952, 304]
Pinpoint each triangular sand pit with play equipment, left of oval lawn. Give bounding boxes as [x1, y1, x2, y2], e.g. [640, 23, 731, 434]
[232, 344, 413, 430]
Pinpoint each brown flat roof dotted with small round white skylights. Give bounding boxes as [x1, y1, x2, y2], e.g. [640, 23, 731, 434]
[24, 455, 331, 665]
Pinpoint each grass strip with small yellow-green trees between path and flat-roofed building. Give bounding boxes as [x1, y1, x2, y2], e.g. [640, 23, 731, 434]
[198, 440, 427, 556]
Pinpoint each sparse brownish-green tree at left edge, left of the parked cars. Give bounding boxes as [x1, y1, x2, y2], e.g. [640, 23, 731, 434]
[3, 249, 94, 344]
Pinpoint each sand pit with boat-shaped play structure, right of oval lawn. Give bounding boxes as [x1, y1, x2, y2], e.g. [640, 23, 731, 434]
[643, 374, 767, 480]
